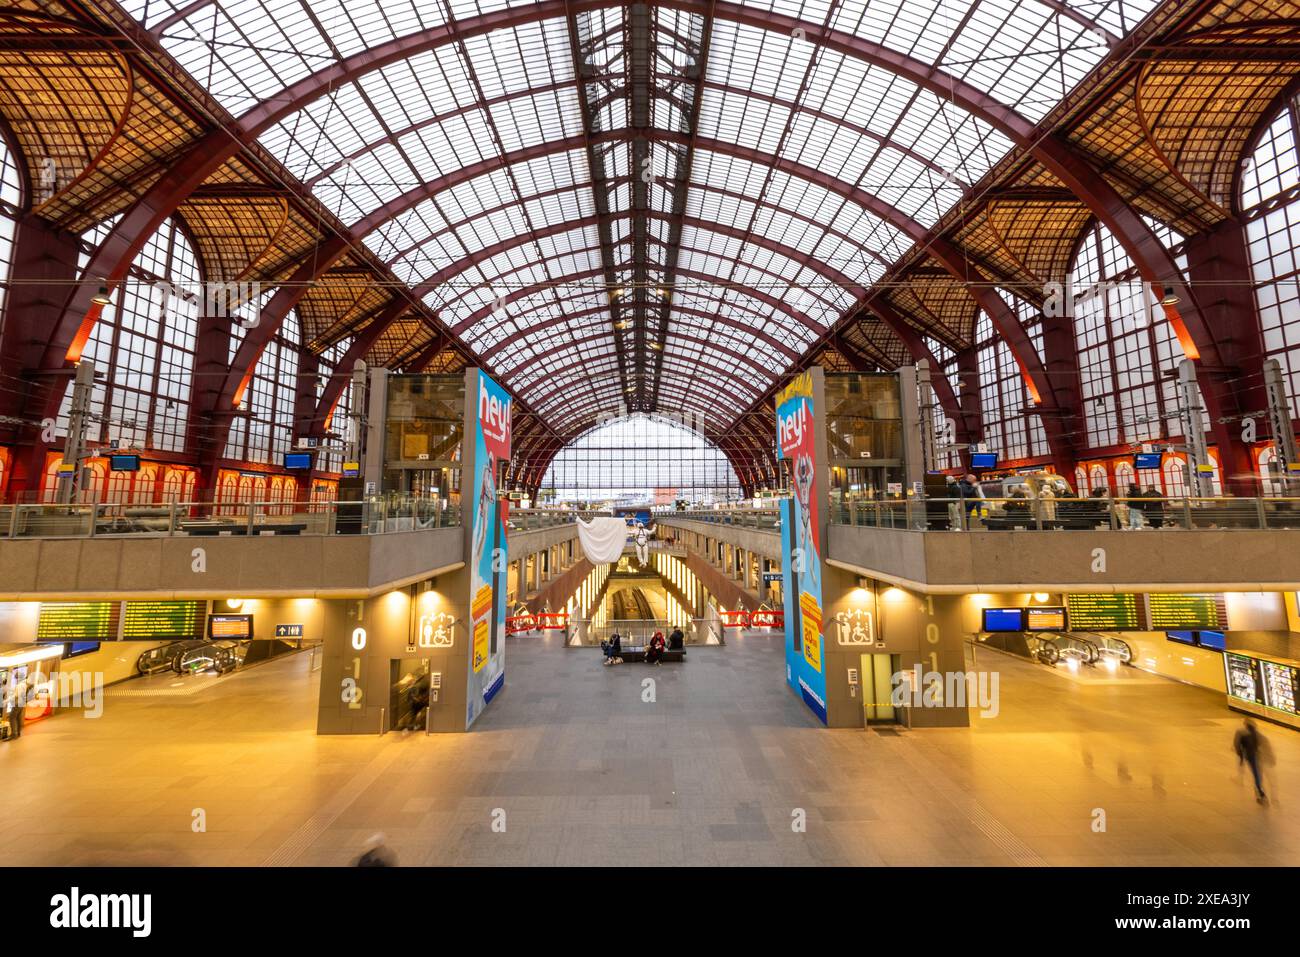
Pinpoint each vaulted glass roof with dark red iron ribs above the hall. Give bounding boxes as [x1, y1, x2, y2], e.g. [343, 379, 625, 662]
[125, 0, 1154, 432]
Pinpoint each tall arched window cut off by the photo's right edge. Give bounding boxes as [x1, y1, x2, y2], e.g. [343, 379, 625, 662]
[1242, 100, 1300, 416]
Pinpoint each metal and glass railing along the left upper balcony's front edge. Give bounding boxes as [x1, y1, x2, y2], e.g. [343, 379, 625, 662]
[0, 495, 462, 538]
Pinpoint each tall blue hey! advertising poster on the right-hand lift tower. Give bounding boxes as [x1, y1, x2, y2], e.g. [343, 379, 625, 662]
[776, 372, 827, 724]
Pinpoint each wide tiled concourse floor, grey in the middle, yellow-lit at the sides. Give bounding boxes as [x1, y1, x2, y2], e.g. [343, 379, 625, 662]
[0, 636, 1300, 865]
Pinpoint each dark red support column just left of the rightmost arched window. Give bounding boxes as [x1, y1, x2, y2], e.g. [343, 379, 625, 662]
[1184, 218, 1268, 495]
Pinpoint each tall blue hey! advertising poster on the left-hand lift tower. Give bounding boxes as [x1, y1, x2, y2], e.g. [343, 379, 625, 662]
[465, 371, 511, 728]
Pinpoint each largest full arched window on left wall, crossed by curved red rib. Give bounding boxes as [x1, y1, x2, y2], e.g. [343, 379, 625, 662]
[59, 220, 200, 451]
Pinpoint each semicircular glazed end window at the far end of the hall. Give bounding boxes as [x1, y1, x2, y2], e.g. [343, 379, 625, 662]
[540, 415, 741, 505]
